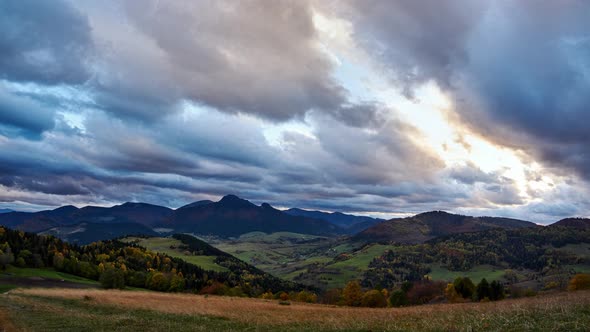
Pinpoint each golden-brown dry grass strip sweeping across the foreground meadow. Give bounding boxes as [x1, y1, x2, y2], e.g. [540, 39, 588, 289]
[8, 289, 590, 330]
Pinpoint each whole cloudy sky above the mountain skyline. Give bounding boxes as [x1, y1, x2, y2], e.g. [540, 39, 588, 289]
[0, 0, 590, 224]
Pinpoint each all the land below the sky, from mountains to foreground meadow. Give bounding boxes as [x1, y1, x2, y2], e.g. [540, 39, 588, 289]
[0, 195, 590, 331]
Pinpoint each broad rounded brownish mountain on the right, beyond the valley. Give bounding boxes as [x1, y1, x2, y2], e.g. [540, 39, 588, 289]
[353, 211, 537, 244]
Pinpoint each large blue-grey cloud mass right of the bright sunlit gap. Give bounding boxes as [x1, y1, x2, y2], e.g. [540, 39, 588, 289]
[348, 1, 590, 178]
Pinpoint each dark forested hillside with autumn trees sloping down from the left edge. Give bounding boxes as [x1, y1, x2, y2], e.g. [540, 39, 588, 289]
[0, 227, 304, 296]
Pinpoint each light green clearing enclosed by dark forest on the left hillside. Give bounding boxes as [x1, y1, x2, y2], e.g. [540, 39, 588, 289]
[123, 237, 228, 272]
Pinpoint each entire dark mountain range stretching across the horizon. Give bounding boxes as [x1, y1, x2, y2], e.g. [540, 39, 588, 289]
[0, 195, 588, 244]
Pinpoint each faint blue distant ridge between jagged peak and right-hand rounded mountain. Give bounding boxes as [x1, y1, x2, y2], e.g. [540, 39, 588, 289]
[283, 208, 386, 234]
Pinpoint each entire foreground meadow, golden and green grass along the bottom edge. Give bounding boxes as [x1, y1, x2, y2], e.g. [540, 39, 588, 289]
[0, 289, 590, 331]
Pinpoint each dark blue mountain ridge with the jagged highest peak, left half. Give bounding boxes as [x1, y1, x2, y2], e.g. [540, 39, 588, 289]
[0, 195, 345, 242]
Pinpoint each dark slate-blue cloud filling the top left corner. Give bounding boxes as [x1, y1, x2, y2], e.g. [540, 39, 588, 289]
[0, 0, 92, 84]
